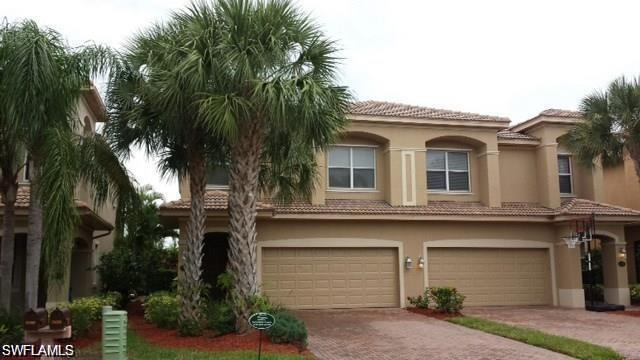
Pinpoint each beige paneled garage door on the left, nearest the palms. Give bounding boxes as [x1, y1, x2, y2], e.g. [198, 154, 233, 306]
[262, 248, 399, 309]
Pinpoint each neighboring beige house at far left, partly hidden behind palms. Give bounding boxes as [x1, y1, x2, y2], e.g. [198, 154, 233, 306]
[0, 87, 115, 310]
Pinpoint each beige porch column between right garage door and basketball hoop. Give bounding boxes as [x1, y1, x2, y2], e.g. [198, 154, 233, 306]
[554, 225, 585, 308]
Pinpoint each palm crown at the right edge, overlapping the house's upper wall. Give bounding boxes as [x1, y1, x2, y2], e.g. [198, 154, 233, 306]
[562, 77, 640, 176]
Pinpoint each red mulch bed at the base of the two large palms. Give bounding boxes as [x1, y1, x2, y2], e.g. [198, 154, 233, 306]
[129, 316, 310, 355]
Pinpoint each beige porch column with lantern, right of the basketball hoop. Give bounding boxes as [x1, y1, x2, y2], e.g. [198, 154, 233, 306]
[602, 241, 631, 306]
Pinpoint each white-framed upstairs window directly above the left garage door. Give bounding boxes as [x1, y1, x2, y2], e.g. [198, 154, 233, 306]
[328, 146, 376, 189]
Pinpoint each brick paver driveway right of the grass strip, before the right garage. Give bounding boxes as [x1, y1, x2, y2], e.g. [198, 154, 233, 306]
[464, 307, 640, 359]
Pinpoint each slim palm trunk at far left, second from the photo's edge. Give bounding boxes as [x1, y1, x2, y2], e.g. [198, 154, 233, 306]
[24, 156, 42, 309]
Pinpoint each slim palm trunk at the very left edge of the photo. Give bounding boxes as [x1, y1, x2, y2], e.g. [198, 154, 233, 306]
[0, 184, 18, 311]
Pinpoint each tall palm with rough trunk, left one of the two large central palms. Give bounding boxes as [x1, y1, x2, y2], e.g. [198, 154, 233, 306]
[105, 18, 225, 328]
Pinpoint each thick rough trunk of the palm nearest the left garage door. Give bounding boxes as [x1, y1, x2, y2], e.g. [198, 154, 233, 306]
[228, 120, 262, 333]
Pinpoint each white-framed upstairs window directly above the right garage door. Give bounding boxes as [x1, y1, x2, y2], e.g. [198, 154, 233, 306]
[427, 150, 470, 192]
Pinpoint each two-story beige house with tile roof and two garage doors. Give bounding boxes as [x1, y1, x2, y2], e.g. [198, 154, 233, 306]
[161, 101, 640, 309]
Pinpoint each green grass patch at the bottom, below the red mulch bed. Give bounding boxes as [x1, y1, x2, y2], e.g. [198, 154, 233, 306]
[127, 331, 309, 360]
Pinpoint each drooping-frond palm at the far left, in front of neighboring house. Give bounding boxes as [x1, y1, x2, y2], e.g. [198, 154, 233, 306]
[3, 20, 135, 308]
